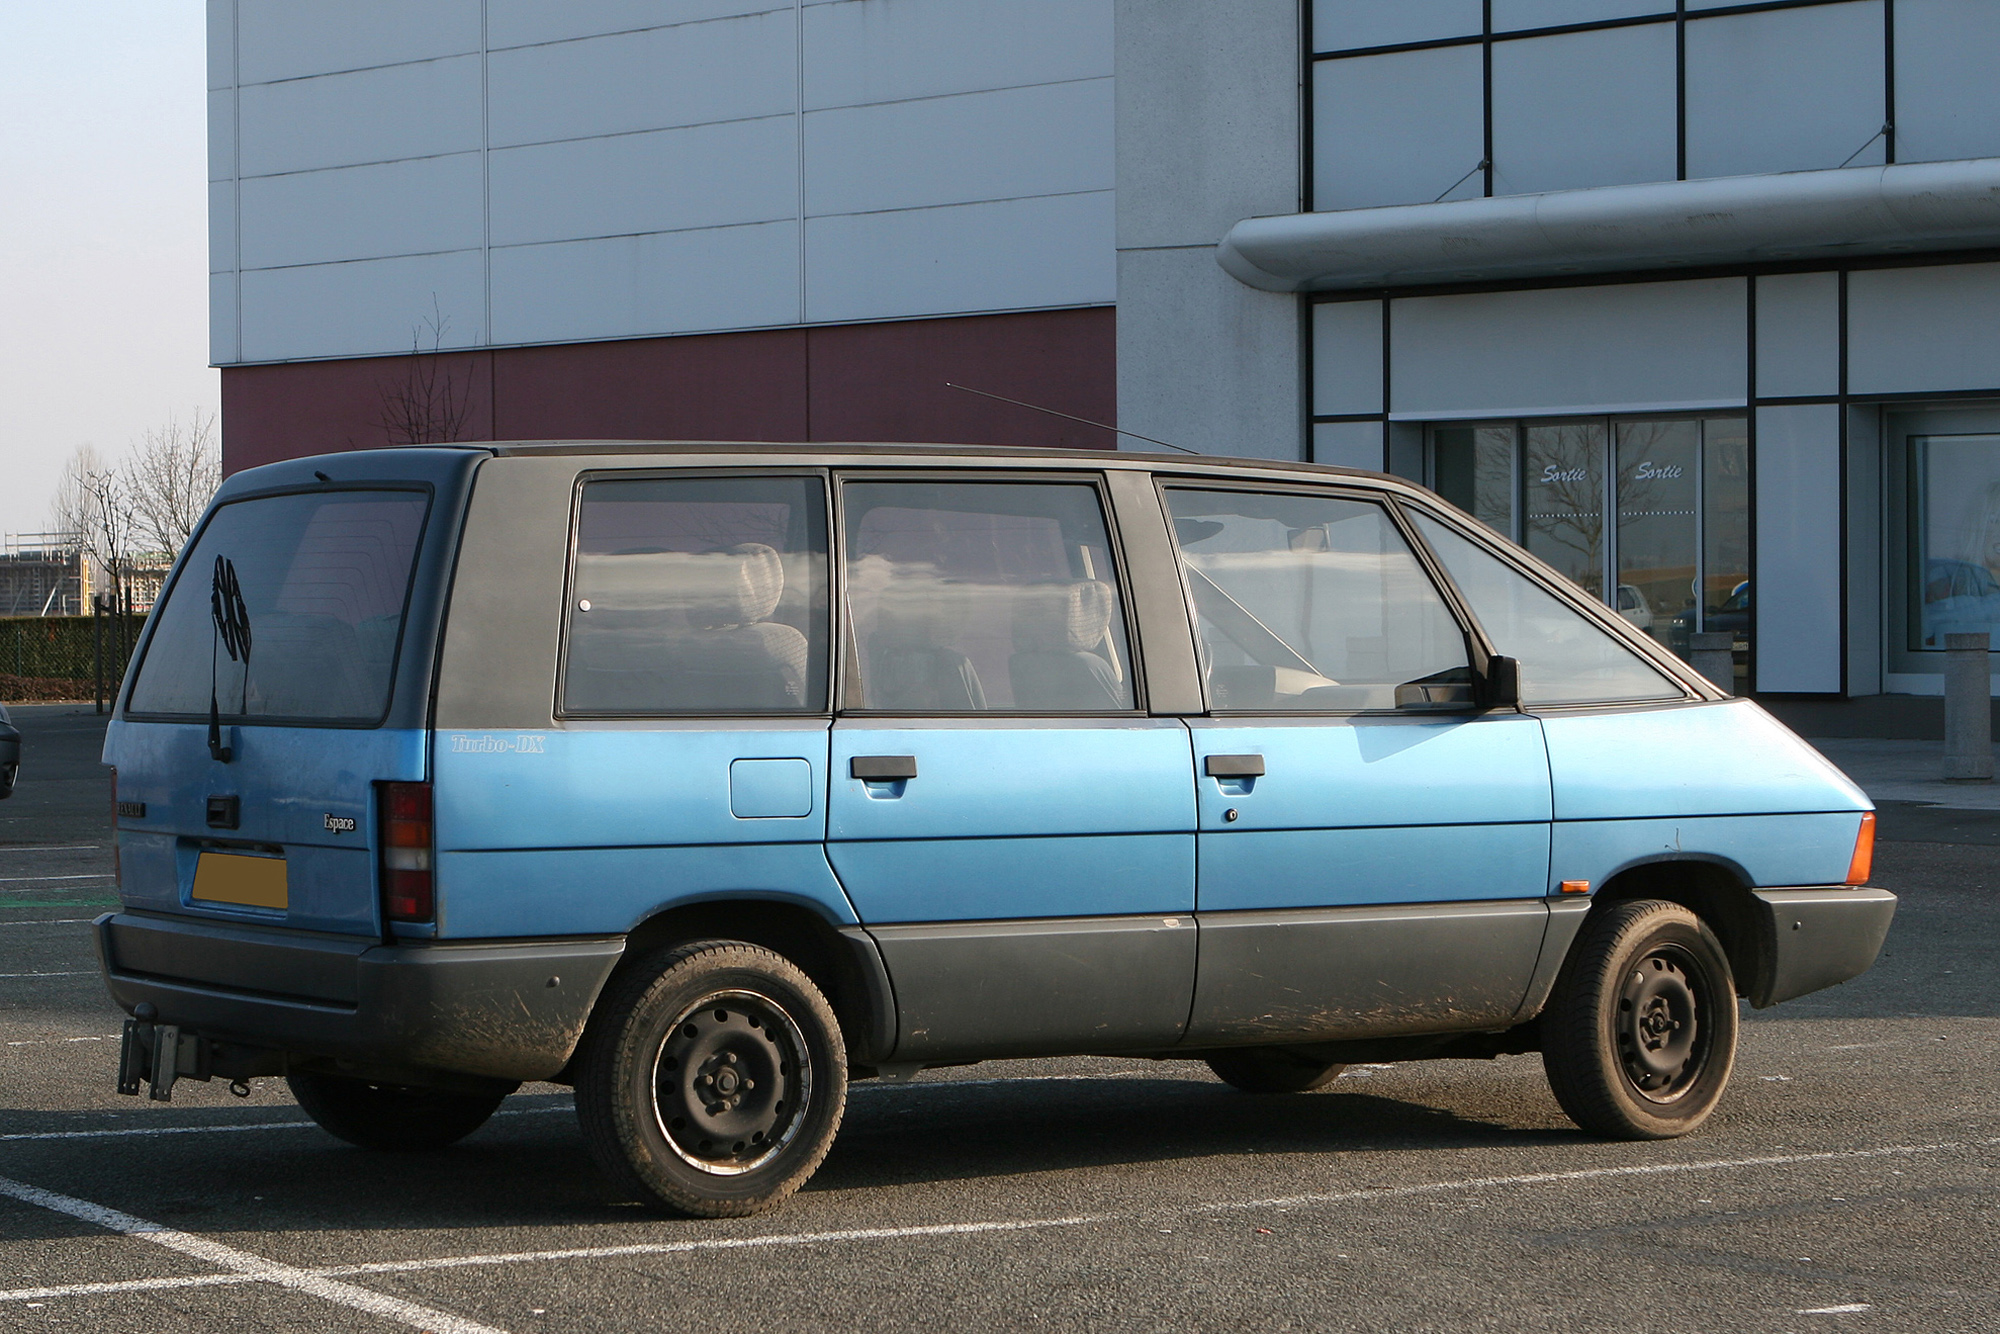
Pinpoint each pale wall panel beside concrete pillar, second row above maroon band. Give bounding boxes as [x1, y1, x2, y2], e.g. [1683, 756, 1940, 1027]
[806, 78, 1116, 214]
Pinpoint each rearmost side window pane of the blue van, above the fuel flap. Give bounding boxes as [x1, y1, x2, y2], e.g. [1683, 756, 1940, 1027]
[562, 478, 828, 714]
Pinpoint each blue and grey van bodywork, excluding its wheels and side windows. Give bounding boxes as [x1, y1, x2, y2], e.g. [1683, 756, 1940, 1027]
[98, 444, 1894, 1084]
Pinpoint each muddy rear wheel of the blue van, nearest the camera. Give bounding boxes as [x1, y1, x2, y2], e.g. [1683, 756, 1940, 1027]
[576, 940, 848, 1218]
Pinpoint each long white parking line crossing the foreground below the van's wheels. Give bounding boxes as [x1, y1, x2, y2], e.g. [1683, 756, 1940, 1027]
[0, 1136, 1968, 1328]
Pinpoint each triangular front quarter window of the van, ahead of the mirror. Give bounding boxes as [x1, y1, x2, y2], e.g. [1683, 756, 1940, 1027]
[1410, 510, 1682, 704]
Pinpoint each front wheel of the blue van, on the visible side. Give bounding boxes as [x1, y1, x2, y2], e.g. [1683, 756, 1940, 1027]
[1542, 900, 1736, 1140]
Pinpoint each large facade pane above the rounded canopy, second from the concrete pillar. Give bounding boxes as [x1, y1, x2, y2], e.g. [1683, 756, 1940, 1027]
[1492, 24, 1680, 194]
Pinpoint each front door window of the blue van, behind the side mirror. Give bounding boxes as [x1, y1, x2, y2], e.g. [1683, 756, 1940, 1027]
[1166, 488, 1472, 712]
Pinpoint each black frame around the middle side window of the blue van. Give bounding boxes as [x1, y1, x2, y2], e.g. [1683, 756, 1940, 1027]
[830, 468, 1148, 722]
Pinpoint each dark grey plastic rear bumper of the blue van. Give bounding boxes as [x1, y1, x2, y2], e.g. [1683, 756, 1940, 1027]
[96, 912, 624, 1080]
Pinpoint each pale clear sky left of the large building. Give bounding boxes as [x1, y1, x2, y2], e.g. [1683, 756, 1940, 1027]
[0, 0, 218, 532]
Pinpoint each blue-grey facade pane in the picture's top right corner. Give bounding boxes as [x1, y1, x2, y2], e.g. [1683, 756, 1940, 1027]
[1896, 0, 2000, 162]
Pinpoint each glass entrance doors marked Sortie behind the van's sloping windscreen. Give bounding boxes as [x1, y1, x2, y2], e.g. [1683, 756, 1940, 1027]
[1426, 414, 1752, 688]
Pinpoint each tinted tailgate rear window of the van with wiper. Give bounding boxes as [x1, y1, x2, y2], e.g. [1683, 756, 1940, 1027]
[128, 490, 430, 724]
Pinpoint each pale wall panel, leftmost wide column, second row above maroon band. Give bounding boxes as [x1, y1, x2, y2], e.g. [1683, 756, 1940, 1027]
[242, 152, 484, 268]
